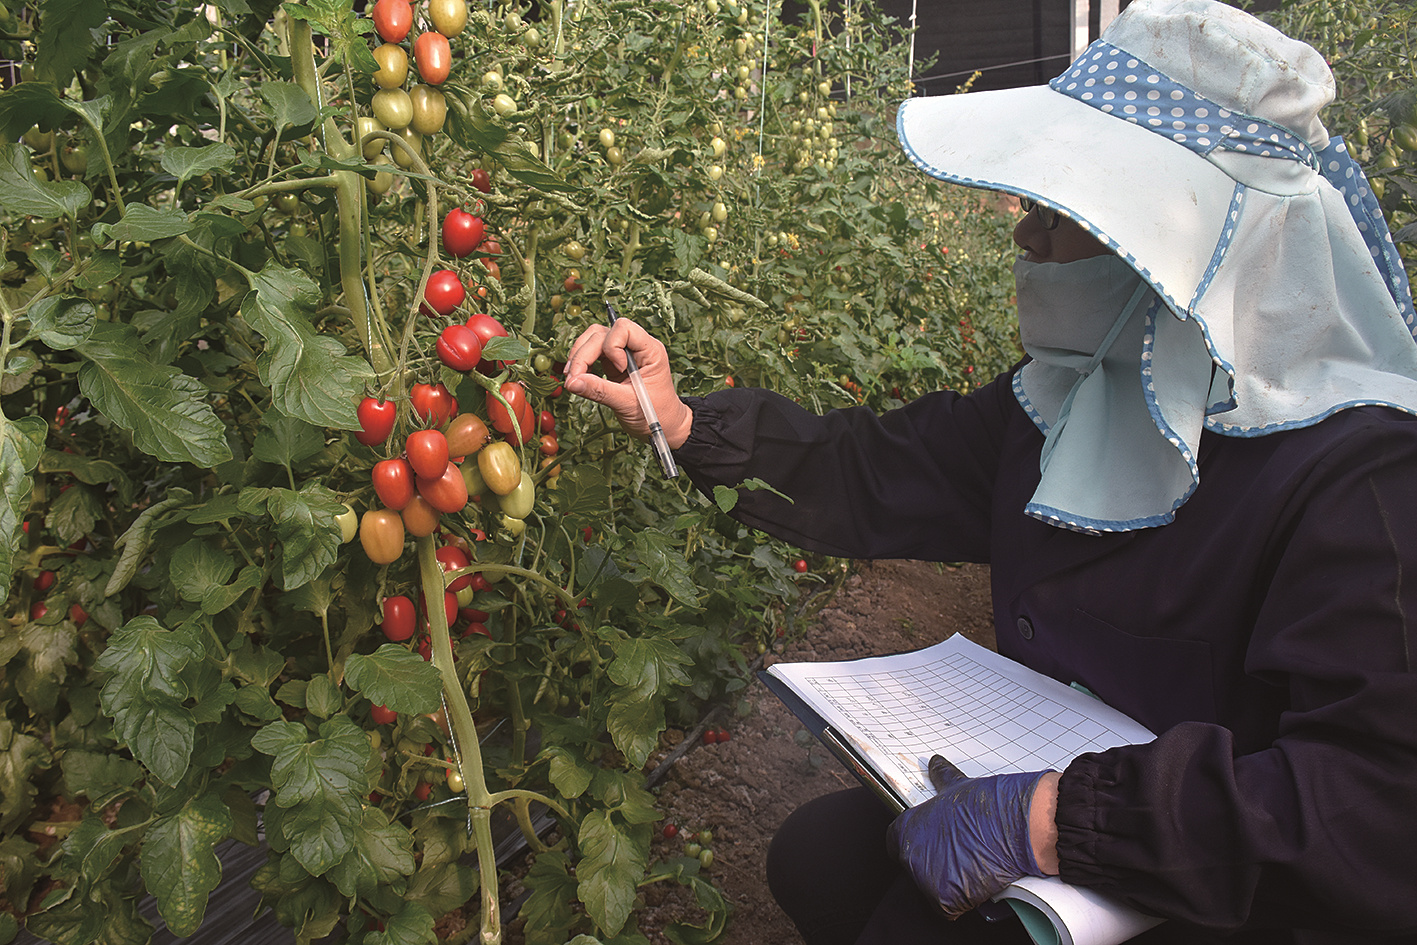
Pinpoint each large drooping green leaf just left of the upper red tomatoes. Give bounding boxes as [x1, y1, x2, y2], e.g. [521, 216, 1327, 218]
[241, 264, 374, 429]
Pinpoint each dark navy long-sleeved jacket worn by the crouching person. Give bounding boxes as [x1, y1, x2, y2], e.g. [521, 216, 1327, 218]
[677, 375, 1417, 942]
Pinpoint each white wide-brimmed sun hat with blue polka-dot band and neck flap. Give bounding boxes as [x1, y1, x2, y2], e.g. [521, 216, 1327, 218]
[897, 0, 1417, 531]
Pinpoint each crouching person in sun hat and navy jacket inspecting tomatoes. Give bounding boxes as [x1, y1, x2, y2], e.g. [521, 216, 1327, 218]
[565, 0, 1417, 945]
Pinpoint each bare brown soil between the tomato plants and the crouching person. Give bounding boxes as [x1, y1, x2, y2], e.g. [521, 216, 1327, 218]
[640, 561, 993, 945]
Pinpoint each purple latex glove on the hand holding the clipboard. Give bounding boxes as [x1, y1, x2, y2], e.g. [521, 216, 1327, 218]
[886, 755, 1047, 919]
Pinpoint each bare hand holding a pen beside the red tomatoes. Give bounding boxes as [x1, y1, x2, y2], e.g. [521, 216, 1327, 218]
[565, 319, 694, 449]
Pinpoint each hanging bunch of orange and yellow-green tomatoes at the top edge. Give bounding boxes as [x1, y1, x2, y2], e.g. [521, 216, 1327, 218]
[359, 0, 468, 193]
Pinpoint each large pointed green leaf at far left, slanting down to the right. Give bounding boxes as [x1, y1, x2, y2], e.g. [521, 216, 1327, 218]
[79, 322, 231, 469]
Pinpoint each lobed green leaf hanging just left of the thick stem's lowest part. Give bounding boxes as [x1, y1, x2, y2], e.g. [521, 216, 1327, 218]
[251, 715, 368, 876]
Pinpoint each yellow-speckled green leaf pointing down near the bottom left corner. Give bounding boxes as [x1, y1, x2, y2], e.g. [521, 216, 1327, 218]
[139, 795, 232, 938]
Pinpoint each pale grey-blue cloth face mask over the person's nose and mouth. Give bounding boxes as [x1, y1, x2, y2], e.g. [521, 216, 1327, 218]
[1013, 254, 1145, 373]
